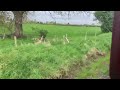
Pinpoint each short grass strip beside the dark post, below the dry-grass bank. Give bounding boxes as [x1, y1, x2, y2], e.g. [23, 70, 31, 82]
[76, 55, 110, 79]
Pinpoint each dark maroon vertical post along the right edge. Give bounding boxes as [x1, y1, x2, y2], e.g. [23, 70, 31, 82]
[110, 11, 120, 79]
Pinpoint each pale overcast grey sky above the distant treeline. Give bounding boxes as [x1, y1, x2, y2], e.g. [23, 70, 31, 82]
[28, 11, 98, 24]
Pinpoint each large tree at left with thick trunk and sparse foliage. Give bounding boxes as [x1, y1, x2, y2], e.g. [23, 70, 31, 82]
[0, 11, 28, 38]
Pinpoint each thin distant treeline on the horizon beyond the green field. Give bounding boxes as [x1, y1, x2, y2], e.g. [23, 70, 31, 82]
[26, 21, 100, 27]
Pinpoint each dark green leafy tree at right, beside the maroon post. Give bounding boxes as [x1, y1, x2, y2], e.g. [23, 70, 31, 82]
[94, 11, 113, 32]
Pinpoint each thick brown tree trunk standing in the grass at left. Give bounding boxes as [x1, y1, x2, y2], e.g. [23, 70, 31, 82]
[13, 11, 24, 38]
